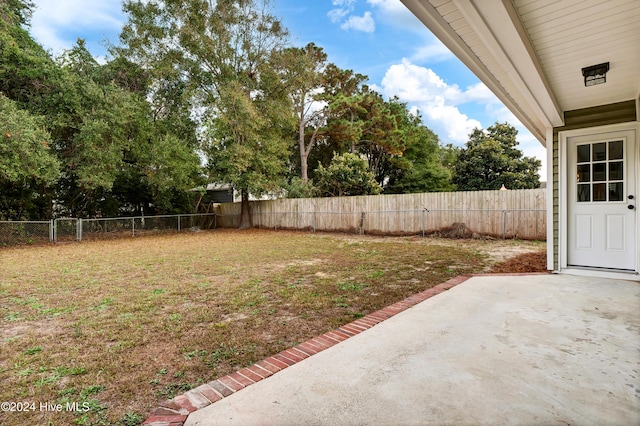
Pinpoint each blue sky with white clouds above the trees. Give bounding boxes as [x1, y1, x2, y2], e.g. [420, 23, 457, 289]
[31, 0, 546, 180]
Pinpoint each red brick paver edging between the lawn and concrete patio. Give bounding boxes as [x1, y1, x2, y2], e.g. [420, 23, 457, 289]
[143, 272, 547, 426]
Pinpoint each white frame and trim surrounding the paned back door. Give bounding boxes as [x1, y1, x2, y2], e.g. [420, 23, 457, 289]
[558, 121, 640, 279]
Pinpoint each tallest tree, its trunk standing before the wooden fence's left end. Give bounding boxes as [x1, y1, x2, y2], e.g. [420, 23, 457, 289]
[121, 0, 291, 228]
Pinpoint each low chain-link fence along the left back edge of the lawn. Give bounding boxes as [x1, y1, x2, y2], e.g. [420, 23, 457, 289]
[0, 213, 216, 246]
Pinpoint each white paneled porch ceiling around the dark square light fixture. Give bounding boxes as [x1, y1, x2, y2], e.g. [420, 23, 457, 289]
[512, 0, 640, 111]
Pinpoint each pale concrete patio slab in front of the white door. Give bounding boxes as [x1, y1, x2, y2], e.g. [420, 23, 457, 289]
[147, 275, 640, 426]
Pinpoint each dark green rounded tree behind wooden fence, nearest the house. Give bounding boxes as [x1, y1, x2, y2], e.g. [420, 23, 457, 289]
[452, 122, 541, 191]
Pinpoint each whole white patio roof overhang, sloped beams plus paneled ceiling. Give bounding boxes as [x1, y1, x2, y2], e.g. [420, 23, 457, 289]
[401, 0, 640, 145]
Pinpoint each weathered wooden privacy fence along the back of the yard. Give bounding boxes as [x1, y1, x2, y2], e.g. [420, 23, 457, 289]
[216, 189, 546, 240]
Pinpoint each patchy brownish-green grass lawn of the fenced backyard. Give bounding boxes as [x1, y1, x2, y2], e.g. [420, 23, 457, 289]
[0, 230, 540, 426]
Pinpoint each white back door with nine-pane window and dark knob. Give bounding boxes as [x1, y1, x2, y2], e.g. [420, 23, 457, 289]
[567, 130, 637, 270]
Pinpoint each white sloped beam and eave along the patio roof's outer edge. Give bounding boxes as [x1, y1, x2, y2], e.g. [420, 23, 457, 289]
[402, 0, 563, 144]
